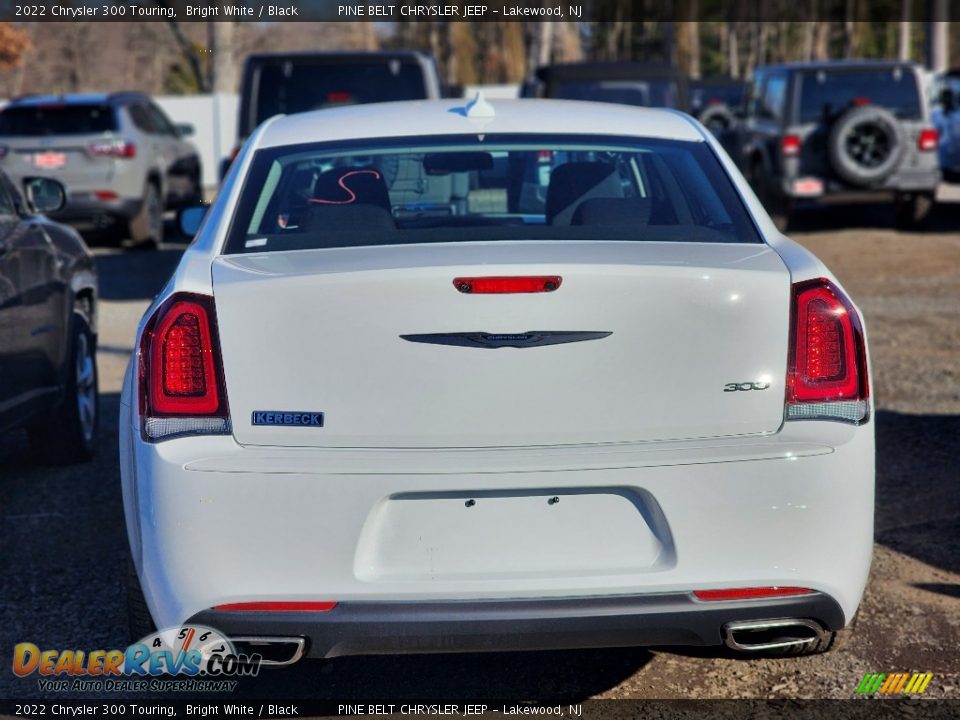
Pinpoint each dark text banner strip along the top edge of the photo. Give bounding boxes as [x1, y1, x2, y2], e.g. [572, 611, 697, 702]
[0, 0, 926, 23]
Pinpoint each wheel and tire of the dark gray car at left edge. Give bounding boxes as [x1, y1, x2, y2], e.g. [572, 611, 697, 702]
[28, 308, 100, 465]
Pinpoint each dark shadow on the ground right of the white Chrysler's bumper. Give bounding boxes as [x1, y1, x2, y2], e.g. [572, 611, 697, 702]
[876, 410, 960, 580]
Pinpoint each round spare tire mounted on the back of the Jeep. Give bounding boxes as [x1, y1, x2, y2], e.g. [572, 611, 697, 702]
[827, 105, 905, 185]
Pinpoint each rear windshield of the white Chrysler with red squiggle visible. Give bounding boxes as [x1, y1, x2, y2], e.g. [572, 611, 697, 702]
[227, 135, 760, 253]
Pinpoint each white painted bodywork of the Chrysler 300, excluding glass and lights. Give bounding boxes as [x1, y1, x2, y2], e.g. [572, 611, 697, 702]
[120, 100, 874, 656]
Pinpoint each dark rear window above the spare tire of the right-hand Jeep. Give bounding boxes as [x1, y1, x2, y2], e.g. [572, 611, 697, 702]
[800, 67, 922, 122]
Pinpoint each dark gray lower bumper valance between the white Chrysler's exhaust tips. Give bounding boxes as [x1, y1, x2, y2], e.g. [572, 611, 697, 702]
[190, 593, 845, 658]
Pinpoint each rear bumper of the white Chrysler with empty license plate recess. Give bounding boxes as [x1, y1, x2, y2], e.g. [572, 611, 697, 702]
[121, 394, 874, 653]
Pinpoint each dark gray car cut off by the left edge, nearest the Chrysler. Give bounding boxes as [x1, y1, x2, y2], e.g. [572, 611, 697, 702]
[0, 171, 98, 462]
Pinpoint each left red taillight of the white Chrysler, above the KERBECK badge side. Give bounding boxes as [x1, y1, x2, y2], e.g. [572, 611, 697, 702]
[139, 293, 230, 440]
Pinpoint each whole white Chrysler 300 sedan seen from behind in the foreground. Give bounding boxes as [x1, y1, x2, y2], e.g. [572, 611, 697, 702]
[120, 98, 874, 664]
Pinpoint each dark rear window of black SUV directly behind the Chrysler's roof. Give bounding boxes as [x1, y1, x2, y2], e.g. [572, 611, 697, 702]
[241, 58, 427, 135]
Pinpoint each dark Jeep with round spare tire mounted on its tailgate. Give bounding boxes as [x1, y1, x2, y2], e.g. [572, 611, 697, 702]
[722, 61, 940, 229]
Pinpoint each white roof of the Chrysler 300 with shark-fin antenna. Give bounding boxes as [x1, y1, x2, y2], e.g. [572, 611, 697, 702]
[257, 99, 704, 147]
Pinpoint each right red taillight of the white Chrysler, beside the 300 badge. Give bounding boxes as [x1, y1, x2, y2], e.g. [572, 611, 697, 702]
[787, 278, 870, 424]
